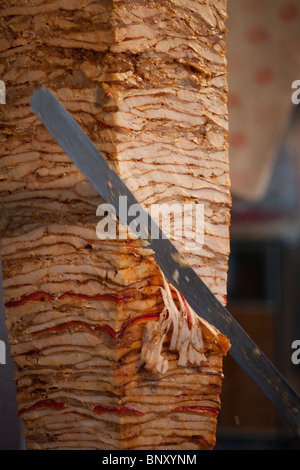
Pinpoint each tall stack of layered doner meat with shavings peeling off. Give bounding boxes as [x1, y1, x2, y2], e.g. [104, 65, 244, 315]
[0, 0, 230, 449]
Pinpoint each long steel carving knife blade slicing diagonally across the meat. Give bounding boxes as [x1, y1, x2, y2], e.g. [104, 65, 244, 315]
[31, 88, 300, 437]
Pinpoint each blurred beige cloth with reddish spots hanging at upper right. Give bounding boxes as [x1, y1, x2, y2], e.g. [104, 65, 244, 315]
[227, 0, 300, 202]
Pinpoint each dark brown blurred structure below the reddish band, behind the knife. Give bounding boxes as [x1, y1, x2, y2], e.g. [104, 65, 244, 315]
[216, 240, 300, 450]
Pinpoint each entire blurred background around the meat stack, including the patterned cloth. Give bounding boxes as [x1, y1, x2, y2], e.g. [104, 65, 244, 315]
[0, 0, 300, 450]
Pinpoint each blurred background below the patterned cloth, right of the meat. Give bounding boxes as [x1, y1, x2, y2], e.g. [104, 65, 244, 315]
[216, 106, 300, 450]
